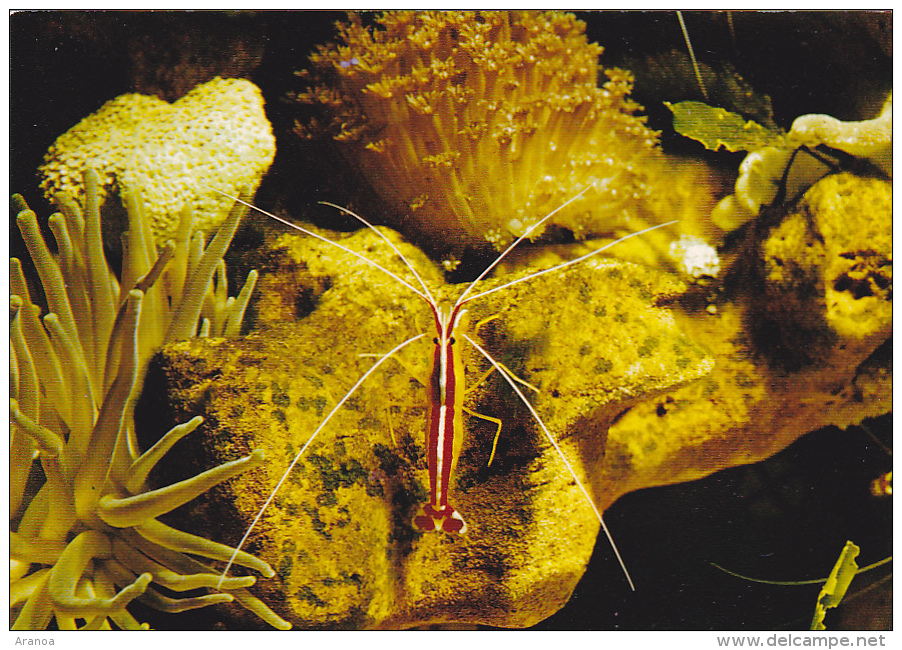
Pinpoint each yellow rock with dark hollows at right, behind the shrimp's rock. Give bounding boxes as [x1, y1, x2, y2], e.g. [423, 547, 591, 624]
[606, 174, 892, 493]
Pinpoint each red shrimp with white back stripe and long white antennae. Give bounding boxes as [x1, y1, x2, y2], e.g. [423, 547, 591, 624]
[201, 185, 675, 624]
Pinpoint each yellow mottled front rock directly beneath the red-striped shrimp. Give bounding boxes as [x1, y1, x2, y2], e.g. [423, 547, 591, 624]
[148, 225, 712, 628]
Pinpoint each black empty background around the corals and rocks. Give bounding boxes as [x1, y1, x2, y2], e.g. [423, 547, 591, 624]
[10, 11, 892, 630]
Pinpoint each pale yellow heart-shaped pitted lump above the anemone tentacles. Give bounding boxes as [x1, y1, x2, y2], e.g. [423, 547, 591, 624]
[41, 78, 275, 245]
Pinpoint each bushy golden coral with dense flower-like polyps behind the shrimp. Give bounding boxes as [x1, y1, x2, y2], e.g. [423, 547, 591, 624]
[298, 11, 708, 253]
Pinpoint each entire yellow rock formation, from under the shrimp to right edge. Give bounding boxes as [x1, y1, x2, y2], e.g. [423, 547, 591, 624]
[153, 176, 892, 628]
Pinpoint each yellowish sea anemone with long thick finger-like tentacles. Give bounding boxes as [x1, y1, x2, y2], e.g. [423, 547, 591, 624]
[10, 171, 287, 629]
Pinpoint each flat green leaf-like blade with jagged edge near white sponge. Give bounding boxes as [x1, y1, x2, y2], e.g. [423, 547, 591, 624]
[664, 102, 783, 152]
